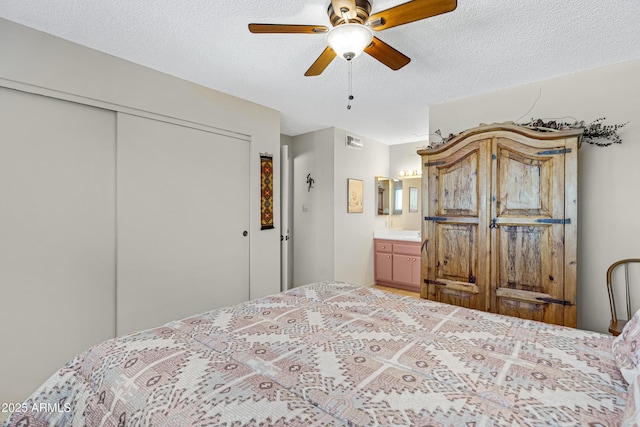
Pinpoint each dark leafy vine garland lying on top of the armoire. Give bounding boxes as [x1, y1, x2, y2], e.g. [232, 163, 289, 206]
[426, 117, 628, 149]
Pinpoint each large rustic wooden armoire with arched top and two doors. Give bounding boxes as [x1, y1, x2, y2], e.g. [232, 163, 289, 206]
[418, 124, 582, 327]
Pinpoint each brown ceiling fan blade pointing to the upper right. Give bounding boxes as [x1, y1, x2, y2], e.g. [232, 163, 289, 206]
[369, 0, 458, 31]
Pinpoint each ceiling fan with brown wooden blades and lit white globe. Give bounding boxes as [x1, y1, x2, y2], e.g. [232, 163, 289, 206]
[249, 0, 457, 76]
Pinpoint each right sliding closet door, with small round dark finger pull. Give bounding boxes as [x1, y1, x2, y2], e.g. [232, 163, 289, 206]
[117, 114, 250, 335]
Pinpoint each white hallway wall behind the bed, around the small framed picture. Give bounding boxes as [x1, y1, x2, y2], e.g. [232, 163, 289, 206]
[291, 128, 389, 286]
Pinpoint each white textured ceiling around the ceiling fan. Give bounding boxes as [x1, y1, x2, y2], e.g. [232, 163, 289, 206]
[0, 0, 640, 144]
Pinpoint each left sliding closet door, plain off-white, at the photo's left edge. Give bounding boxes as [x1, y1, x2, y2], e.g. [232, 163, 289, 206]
[0, 88, 115, 403]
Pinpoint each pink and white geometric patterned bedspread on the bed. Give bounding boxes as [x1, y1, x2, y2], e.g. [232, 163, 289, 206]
[2, 282, 627, 427]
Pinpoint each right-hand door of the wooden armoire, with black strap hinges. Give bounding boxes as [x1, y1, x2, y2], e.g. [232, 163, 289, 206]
[491, 138, 568, 324]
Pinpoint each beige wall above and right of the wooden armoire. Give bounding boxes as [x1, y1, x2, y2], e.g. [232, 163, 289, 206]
[429, 61, 640, 332]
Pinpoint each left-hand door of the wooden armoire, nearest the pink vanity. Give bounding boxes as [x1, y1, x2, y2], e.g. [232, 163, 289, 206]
[421, 141, 489, 310]
